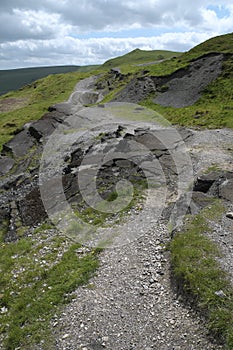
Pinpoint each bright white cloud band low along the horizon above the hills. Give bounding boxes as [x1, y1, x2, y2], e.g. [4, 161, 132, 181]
[0, 32, 215, 69]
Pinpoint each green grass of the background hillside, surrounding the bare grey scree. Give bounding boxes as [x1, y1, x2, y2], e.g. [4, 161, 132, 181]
[0, 34, 233, 152]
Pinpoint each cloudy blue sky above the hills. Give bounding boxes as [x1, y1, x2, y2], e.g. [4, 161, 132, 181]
[0, 0, 233, 70]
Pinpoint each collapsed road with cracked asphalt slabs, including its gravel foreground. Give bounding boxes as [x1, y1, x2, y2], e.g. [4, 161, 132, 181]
[0, 78, 233, 350]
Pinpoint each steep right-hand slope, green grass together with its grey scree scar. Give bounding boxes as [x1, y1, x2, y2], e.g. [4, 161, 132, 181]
[103, 34, 233, 128]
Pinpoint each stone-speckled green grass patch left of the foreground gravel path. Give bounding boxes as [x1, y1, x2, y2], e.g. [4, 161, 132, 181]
[0, 233, 99, 350]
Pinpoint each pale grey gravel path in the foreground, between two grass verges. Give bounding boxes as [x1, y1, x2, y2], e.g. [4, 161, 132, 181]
[53, 223, 221, 350]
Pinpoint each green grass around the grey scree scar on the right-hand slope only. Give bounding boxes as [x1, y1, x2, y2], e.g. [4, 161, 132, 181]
[101, 34, 233, 128]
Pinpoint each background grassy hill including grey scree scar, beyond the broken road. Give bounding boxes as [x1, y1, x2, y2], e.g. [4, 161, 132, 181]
[0, 34, 233, 152]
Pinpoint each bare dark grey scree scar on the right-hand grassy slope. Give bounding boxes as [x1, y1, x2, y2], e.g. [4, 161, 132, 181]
[114, 53, 224, 107]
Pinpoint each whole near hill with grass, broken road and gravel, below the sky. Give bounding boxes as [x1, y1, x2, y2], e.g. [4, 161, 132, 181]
[0, 31, 233, 350]
